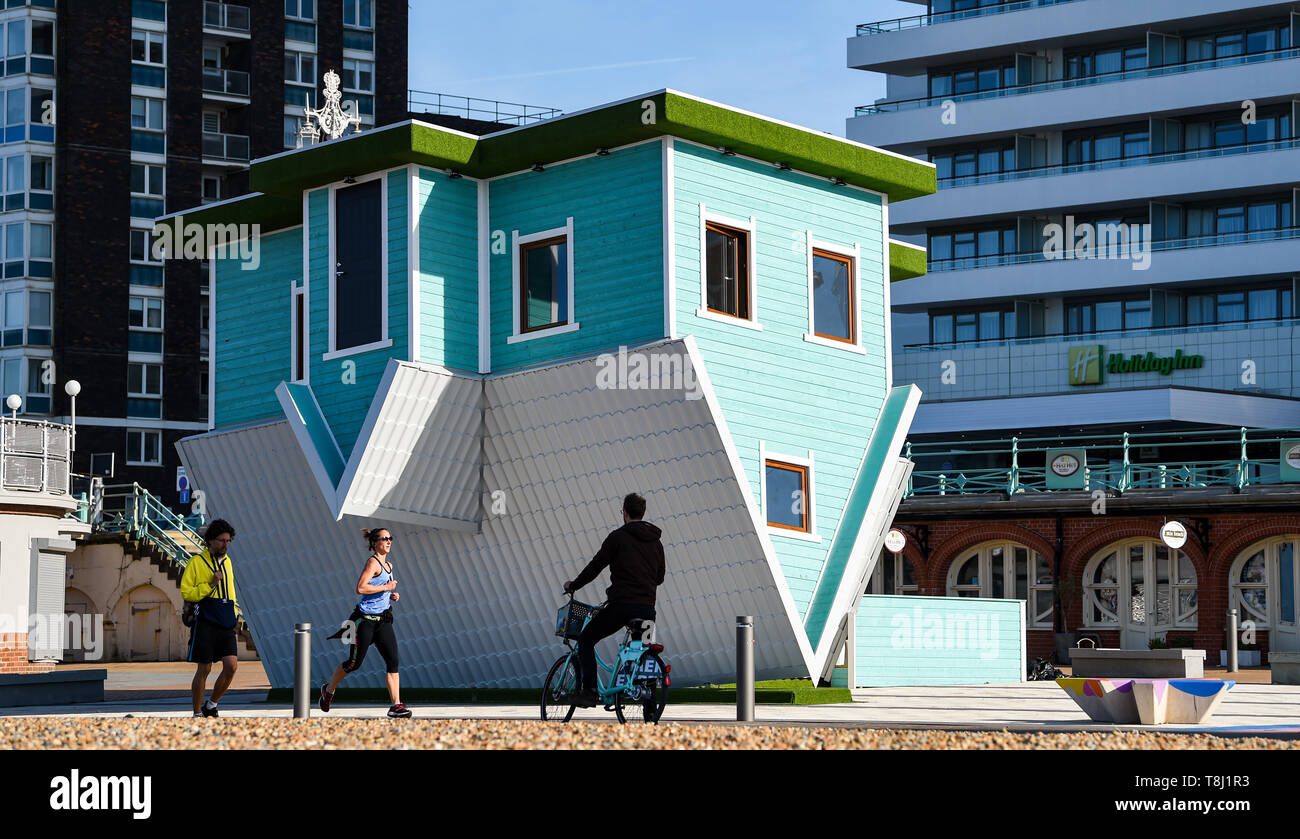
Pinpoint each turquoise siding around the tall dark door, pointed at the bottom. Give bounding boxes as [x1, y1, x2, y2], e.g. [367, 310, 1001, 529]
[308, 168, 410, 458]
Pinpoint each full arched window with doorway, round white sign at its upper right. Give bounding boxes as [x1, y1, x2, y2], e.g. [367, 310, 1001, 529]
[1083, 539, 1197, 649]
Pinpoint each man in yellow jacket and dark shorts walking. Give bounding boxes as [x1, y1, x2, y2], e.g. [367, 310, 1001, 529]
[181, 519, 239, 717]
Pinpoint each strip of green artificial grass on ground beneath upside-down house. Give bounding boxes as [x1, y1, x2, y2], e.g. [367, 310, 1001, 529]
[267, 679, 853, 705]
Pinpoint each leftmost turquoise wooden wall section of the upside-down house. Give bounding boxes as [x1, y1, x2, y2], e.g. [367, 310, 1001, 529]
[209, 228, 303, 428]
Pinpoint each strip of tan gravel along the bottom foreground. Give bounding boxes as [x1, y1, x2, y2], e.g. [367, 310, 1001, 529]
[0, 717, 1300, 751]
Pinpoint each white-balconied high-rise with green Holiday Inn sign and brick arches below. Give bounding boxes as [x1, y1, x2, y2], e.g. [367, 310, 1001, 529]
[848, 0, 1300, 663]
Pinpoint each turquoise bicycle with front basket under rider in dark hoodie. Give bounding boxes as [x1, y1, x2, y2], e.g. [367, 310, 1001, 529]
[542, 593, 672, 723]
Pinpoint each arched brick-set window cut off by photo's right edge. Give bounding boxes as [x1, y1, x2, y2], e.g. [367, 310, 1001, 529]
[1227, 535, 1300, 649]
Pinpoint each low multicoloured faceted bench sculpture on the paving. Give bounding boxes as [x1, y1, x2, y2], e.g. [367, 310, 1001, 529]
[1057, 676, 1236, 726]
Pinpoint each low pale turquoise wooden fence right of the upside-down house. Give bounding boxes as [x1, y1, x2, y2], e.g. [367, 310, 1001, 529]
[853, 594, 1026, 687]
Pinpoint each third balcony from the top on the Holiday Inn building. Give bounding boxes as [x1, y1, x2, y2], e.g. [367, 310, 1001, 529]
[889, 139, 1300, 227]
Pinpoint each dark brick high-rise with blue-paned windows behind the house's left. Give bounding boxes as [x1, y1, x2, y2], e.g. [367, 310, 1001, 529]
[0, 0, 407, 501]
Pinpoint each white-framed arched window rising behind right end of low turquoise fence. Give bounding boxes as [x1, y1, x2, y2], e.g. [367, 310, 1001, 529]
[948, 542, 1052, 628]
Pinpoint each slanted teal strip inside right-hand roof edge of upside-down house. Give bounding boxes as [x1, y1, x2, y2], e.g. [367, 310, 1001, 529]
[803, 388, 911, 649]
